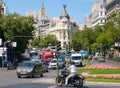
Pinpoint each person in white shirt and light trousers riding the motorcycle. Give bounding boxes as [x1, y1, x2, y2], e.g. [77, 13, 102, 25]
[65, 62, 76, 85]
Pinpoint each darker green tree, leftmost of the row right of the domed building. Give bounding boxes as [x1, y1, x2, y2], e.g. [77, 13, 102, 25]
[72, 28, 95, 50]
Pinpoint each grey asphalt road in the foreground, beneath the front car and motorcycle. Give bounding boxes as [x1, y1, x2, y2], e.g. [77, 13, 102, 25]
[0, 66, 120, 88]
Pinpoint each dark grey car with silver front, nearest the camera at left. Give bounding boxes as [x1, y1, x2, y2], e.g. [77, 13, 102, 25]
[17, 61, 44, 78]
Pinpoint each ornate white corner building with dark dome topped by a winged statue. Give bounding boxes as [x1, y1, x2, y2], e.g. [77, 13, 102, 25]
[49, 5, 78, 48]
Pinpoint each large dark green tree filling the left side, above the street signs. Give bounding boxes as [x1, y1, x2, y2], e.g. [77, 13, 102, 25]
[0, 13, 34, 54]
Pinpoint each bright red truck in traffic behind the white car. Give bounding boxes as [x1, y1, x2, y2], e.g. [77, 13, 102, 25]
[41, 51, 54, 63]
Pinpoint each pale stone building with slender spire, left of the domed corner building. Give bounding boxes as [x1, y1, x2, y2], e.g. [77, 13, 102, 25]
[26, 3, 49, 38]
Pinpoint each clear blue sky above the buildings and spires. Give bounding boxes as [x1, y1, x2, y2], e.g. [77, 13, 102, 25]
[3, 0, 100, 23]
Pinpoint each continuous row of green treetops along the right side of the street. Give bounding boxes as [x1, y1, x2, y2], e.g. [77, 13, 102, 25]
[72, 13, 120, 52]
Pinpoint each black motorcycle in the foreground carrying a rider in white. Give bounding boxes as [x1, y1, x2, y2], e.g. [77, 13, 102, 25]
[56, 69, 84, 88]
